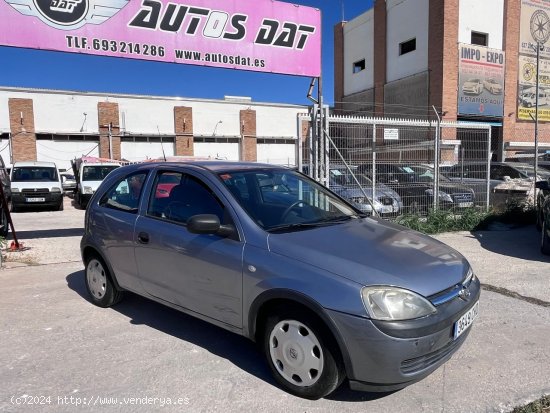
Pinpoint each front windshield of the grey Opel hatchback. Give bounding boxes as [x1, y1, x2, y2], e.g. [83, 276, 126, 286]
[218, 169, 365, 232]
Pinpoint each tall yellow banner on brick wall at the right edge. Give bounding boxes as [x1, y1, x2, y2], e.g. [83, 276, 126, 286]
[517, 0, 550, 122]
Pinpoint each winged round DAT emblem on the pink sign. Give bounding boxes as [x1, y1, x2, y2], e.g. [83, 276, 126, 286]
[4, 0, 129, 30]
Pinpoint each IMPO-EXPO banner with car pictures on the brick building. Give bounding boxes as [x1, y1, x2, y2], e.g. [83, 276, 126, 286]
[458, 43, 505, 117]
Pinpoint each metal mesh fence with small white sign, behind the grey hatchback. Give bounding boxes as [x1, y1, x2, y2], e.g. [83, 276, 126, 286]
[302, 112, 491, 217]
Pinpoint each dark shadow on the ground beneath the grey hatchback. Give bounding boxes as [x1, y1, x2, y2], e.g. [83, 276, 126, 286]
[66, 271, 396, 402]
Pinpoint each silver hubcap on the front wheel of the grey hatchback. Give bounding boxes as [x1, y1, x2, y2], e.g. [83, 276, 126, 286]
[269, 320, 324, 387]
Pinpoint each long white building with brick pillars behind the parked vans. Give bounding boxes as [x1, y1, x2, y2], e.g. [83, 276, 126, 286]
[0, 87, 308, 169]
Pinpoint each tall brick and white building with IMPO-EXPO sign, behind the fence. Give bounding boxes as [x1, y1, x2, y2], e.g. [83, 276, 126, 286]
[334, 0, 550, 159]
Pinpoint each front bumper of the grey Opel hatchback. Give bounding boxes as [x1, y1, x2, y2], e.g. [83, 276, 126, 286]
[328, 281, 480, 392]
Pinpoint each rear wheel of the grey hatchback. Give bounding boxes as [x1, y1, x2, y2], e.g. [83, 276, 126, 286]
[84, 254, 123, 307]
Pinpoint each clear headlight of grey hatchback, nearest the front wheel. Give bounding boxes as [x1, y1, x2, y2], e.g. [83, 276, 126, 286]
[361, 286, 437, 321]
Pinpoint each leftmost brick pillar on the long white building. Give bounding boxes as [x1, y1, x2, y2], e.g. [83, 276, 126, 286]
[8, 98, 36, 163]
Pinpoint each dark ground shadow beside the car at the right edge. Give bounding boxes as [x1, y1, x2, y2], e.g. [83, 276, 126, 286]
[472, 225, 550, 262]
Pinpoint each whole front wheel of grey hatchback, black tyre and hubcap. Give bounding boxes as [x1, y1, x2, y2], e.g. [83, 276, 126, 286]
[263, 308, 345, 400]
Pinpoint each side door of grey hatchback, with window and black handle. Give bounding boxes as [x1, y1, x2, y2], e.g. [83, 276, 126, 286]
[135, 169, 244, 328]
